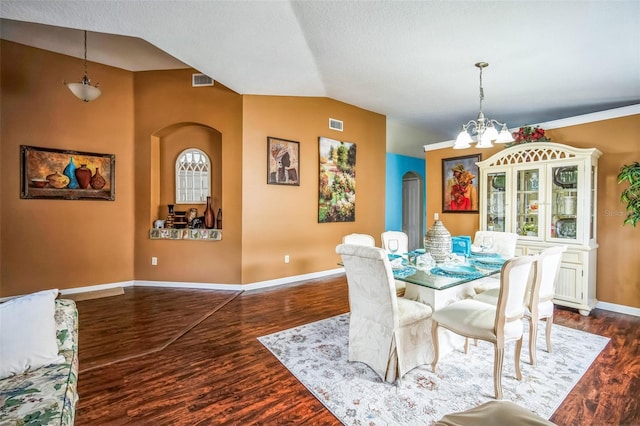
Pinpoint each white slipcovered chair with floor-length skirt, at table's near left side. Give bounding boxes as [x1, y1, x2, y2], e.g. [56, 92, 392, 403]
[336, 244, 436, 383]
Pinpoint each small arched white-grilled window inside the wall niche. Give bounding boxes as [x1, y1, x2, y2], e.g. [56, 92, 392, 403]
[176, 148, 211, 204]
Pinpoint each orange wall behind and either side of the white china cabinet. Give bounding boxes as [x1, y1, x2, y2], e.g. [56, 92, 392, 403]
[426, 115, 640, 308]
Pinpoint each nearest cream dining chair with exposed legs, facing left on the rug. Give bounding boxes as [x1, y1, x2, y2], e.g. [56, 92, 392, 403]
[431, 256, 537, 399]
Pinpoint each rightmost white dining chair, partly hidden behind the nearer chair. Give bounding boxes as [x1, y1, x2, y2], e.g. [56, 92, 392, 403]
[474, 246, 567, 365]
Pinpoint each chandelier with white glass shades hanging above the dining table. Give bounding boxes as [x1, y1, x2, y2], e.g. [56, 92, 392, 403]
[453, 62, 513, 149]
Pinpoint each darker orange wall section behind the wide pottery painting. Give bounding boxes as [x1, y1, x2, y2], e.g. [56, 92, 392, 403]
[0, 40, 134, 296]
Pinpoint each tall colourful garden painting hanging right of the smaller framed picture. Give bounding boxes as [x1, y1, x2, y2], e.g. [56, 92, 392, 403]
[318, 137, 356, 223]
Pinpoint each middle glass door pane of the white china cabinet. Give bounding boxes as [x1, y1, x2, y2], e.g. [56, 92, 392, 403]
[516, 169, 542, 237]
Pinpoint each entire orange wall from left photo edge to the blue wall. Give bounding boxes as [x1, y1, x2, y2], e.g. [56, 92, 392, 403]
[0, 40, 386, 297]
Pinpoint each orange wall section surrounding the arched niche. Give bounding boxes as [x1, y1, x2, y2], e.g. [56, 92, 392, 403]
[135, 69, 243, 284]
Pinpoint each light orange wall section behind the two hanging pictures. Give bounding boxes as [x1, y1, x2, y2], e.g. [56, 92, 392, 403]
[242, 96, 386, 283]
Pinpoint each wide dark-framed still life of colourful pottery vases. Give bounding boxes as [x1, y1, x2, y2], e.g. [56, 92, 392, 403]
[20, 145, 116, 201]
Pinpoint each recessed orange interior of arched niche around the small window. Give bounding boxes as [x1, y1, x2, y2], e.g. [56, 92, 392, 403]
[149, 122, 222, 224]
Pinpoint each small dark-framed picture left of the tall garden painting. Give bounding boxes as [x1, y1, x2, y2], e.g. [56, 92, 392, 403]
[267, 136, 300, 186]
